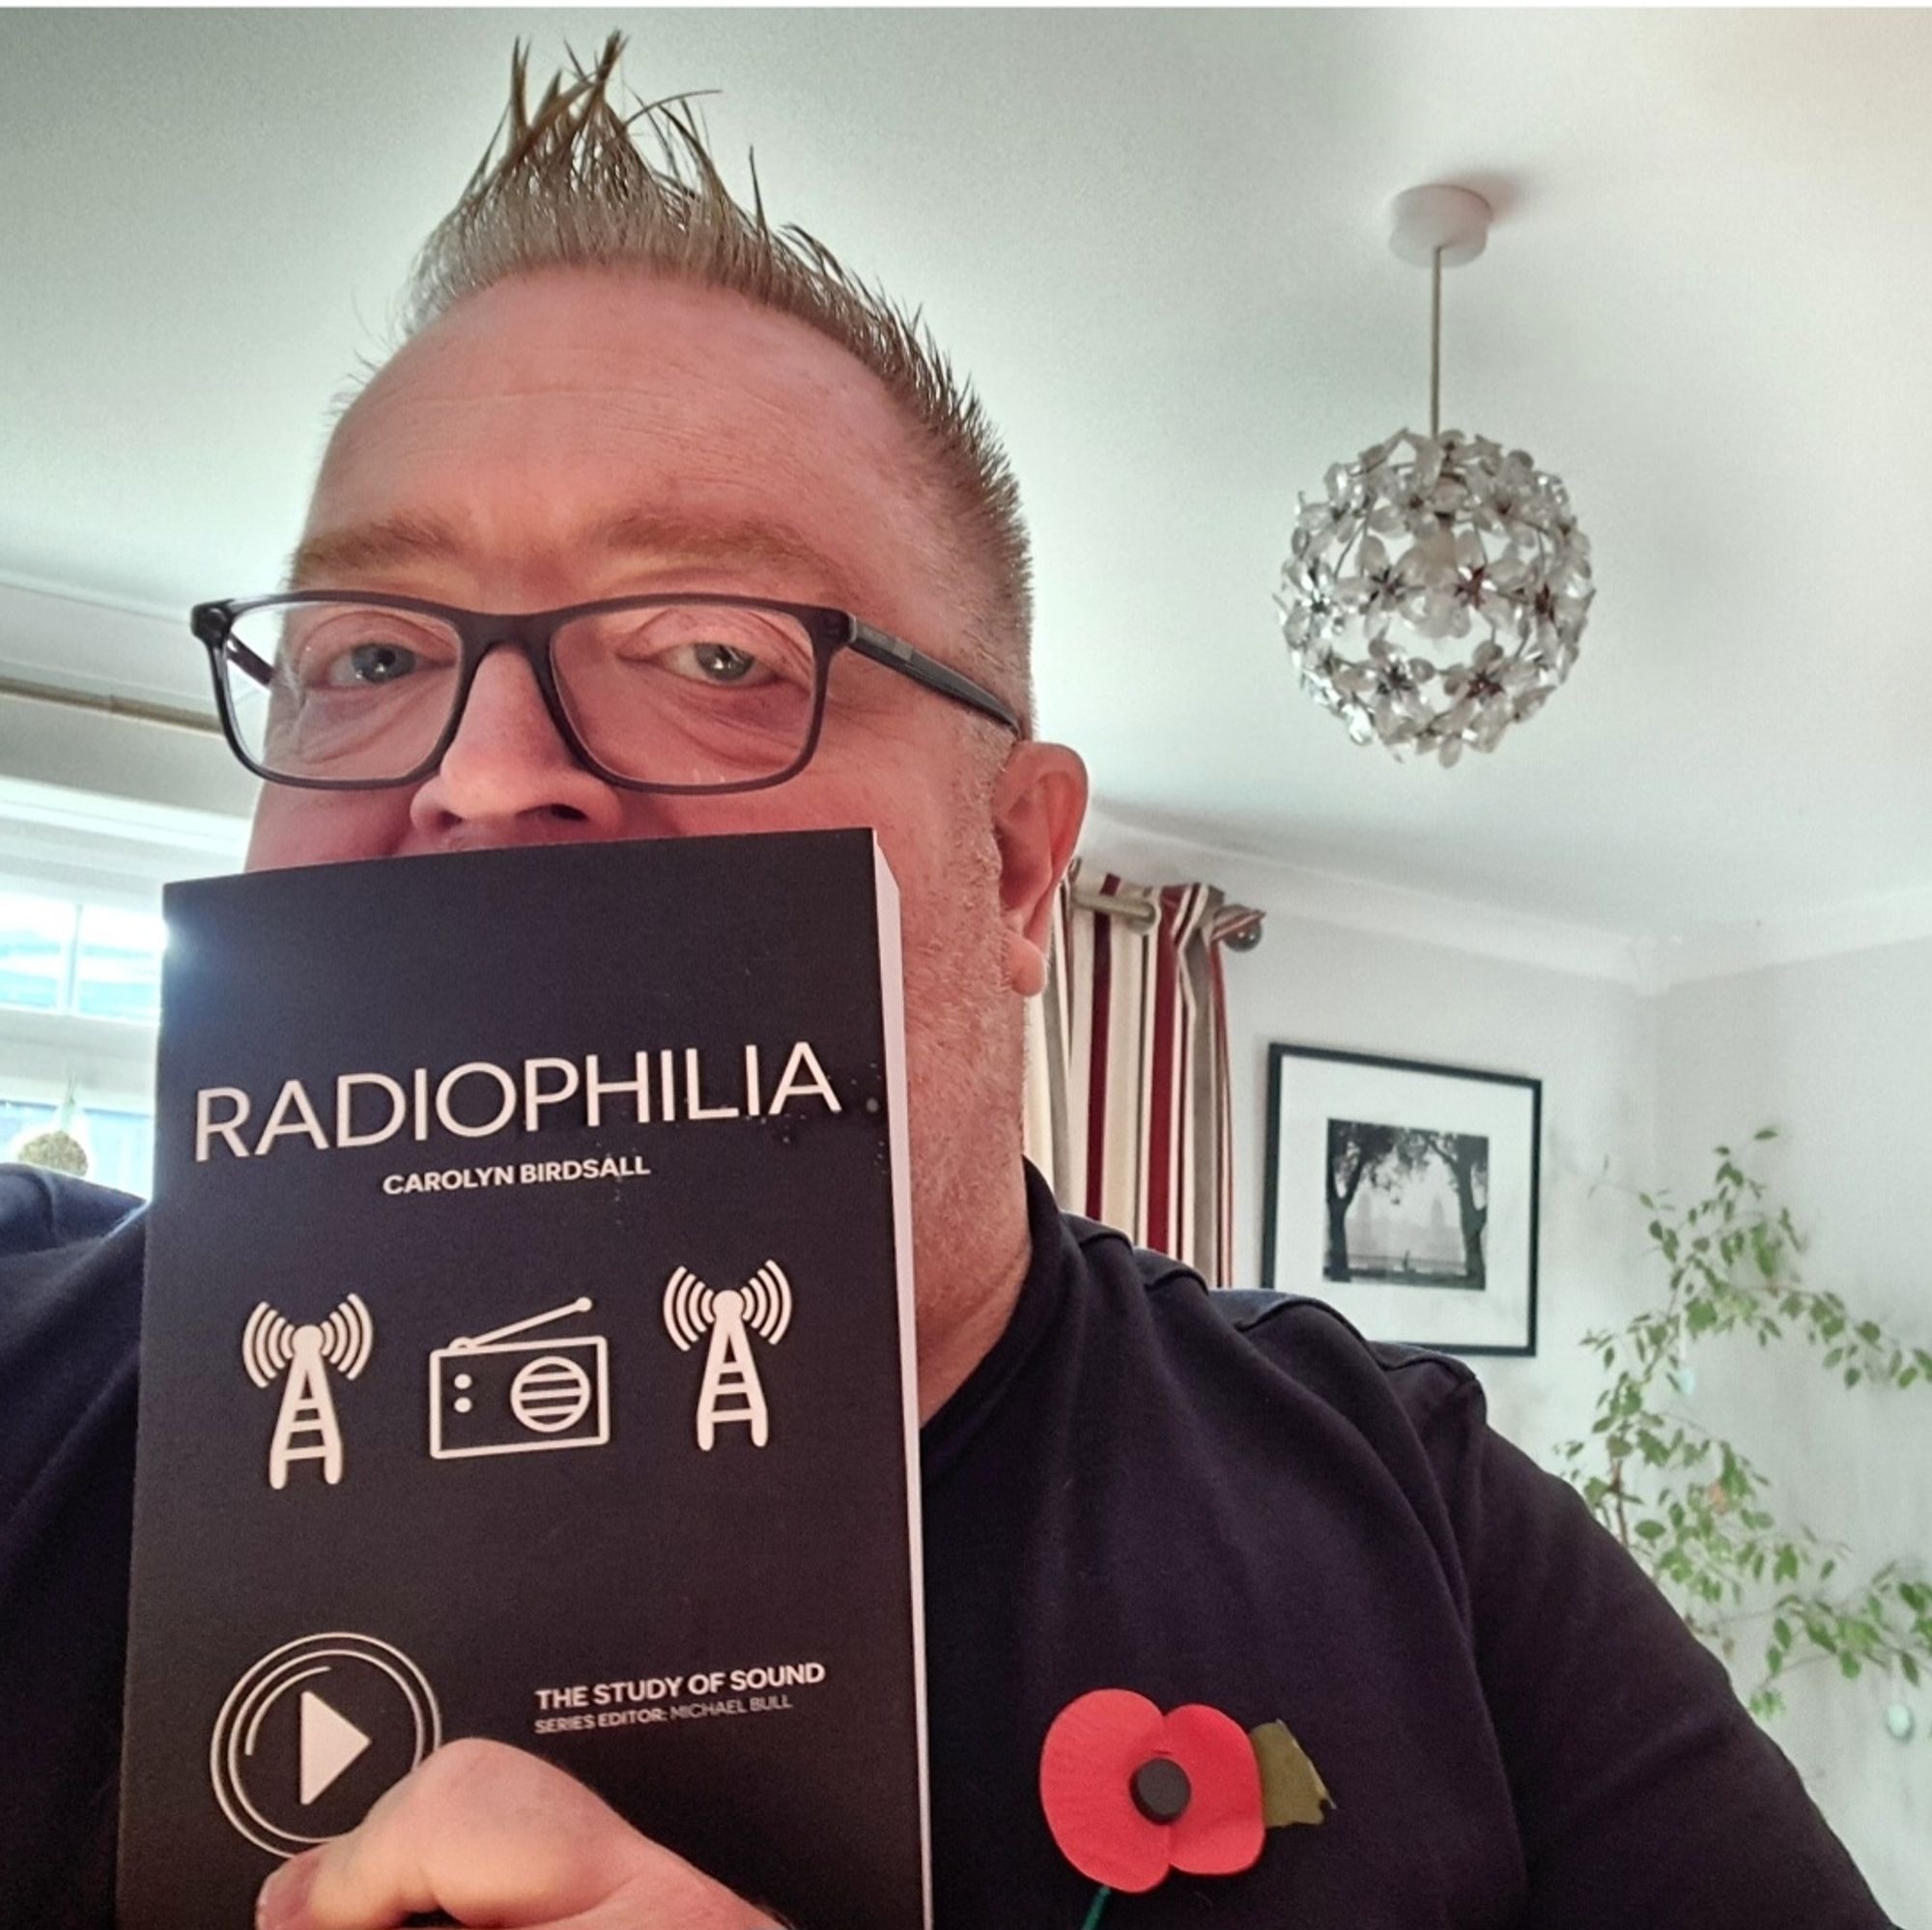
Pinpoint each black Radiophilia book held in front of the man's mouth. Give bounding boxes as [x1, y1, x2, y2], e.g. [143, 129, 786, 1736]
[120, 831, 931, 1930]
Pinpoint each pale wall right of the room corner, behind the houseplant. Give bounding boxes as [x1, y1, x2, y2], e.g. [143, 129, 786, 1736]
[1656, 939, 1932, 1922]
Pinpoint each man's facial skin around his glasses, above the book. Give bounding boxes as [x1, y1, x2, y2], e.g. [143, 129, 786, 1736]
[249, 270, 1080, 1283]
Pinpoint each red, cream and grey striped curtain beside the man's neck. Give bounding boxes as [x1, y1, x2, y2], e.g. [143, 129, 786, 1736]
[1026, 858, 1262, 1287]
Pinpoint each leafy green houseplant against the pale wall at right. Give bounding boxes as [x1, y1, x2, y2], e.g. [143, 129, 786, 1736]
[1557, 1128, 1932, 1741]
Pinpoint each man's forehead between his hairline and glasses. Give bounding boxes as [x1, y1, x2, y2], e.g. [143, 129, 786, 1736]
[296, 270, 949, 622]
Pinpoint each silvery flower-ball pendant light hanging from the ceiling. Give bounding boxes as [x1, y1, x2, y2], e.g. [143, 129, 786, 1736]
[1275, 187, 1596, 765]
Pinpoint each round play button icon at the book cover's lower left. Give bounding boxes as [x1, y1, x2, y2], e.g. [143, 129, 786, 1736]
[209, 1632, 442, 1857]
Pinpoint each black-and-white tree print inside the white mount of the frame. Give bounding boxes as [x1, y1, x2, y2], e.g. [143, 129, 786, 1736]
[1321, 1119, 1490, 1292]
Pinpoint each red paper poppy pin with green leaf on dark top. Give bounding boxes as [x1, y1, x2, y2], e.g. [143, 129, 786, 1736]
[1039, 1689, 1335, 1930]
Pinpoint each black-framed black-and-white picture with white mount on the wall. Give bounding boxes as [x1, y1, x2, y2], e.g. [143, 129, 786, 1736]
[1262, 1045, 1544, 1354]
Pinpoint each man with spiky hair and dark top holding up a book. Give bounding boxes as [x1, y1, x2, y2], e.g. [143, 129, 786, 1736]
[0, 43, 1884, 1930]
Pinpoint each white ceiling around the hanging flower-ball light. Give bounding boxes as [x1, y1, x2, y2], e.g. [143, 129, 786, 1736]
[0, 10, 1932, 933]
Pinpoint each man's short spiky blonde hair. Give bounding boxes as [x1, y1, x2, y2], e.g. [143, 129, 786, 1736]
[402, 33, 1032, 717]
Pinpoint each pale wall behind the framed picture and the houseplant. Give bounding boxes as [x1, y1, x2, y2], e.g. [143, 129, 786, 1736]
[1080, 811, 1932, 1922]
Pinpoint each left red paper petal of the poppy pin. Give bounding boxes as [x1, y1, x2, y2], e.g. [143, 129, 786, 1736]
[1039, 1689, 1167, 1893]
